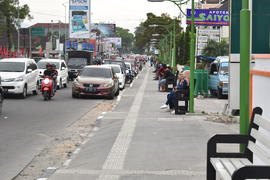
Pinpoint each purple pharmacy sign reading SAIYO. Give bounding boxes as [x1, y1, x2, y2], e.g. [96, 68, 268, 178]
[187, 9, 230, 26]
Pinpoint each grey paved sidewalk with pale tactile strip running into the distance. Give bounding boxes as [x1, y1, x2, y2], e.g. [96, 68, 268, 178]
[50, 68, 237, 180]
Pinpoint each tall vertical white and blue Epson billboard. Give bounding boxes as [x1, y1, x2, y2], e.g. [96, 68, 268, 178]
[69, 0, 90, 39]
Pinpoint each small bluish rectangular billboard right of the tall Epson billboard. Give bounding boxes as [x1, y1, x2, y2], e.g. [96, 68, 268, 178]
[91, 23, 116, 37]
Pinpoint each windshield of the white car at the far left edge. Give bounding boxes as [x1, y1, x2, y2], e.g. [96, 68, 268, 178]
[0, 62, 25, 72]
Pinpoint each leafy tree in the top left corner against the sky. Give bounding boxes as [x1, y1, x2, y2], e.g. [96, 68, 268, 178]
[0, 0, 32, 48]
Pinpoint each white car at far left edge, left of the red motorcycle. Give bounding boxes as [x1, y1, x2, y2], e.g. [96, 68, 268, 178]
[0, 58, 39, 98]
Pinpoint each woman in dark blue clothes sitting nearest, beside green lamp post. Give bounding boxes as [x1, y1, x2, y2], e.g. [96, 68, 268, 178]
[160, 73, 188, 113]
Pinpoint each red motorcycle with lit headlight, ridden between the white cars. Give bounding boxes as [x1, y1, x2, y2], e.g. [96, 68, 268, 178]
[41, 76, 55, 101]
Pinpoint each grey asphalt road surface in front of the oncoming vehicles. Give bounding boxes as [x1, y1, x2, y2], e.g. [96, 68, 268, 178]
[0, 84, 103, 180]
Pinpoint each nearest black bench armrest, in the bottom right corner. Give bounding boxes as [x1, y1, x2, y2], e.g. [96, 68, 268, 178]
[232, 165, 270, 180]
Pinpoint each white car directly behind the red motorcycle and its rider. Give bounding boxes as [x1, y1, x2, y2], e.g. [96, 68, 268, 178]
[37, 59, 68, 89]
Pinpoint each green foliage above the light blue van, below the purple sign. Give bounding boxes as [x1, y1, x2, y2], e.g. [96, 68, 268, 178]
[202, 40, 229, 57]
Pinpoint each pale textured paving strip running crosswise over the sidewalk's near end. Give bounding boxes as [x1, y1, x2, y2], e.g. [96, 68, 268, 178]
[56, 169, 205, 177]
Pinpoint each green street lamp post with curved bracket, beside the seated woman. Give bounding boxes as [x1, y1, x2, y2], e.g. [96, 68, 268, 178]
[148, 0, 195, 113]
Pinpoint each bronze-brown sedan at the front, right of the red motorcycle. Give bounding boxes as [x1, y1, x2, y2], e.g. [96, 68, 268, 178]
[72, 65, 119, 99]
